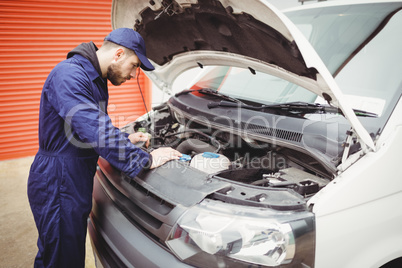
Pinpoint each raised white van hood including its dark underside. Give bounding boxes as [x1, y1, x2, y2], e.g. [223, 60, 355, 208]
[112, 0, 375, 150]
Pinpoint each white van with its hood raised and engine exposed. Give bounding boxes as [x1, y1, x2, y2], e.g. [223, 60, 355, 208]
[88, 0, 402, 268]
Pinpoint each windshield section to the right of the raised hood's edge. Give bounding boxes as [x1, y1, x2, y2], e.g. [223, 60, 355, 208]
[286, 3, 402, 116]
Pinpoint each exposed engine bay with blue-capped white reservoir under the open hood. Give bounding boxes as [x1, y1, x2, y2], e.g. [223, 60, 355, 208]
[122, 96, 331, 203]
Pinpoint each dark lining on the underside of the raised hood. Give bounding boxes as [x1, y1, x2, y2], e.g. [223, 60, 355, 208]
[114, 0, 316, 79]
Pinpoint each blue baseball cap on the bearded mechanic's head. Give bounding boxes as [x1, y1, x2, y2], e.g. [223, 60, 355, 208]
[105, 28, 155, 71]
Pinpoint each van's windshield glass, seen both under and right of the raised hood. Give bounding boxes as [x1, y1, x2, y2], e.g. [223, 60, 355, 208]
[189, 3, 402, 131]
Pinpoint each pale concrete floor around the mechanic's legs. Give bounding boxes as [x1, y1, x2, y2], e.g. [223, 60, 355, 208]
[0, 157, 95, 268]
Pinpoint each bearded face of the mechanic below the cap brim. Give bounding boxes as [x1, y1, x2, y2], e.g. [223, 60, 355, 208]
[107, 54, 141, 86]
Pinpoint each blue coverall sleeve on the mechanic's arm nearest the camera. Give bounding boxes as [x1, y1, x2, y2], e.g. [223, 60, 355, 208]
[48, 64, 152, 177]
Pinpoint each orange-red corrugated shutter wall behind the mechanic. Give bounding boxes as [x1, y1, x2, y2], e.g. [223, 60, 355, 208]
[0, 0, 151, 160]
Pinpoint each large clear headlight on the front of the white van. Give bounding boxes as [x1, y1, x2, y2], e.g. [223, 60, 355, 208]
[166, 200, 315, 267]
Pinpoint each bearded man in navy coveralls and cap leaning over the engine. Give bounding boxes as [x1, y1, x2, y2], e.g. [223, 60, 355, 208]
[28, 28, 181, 268]
